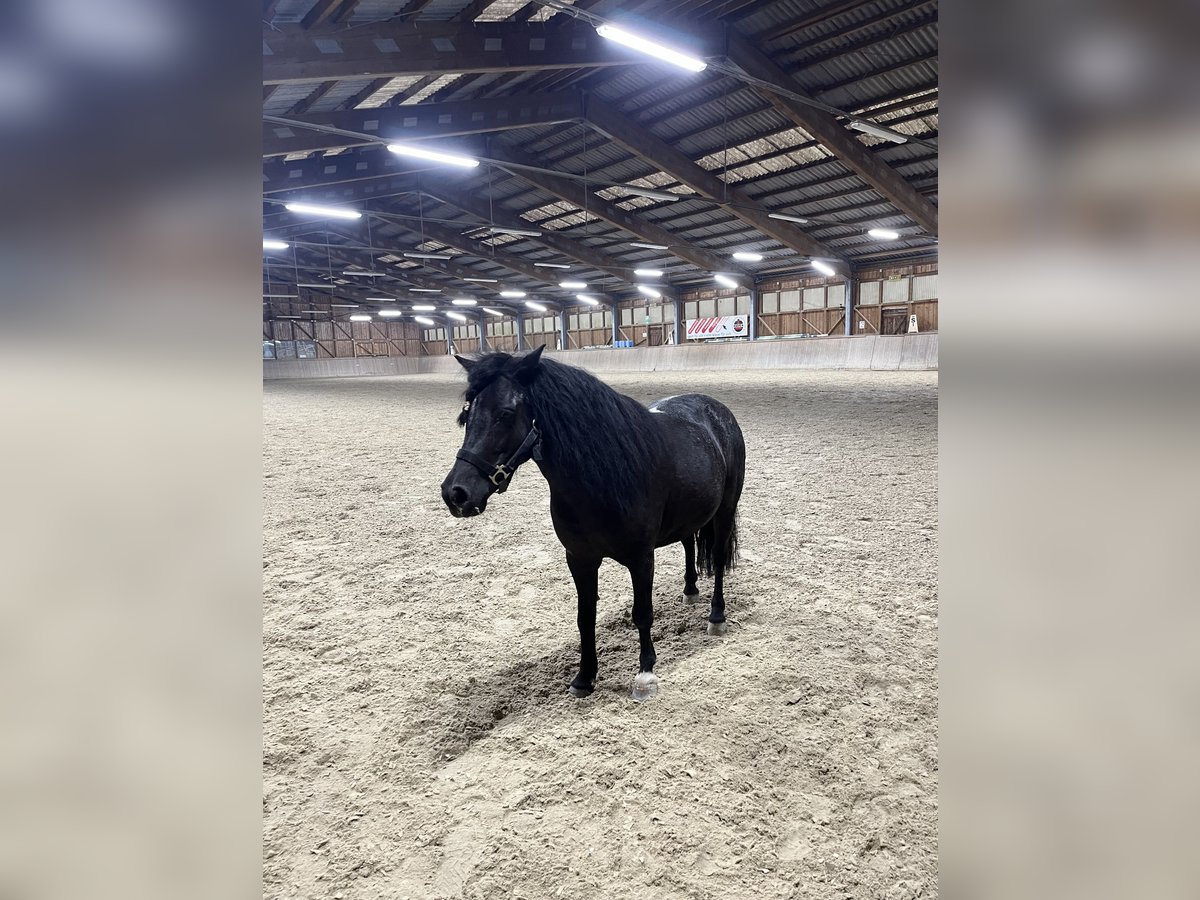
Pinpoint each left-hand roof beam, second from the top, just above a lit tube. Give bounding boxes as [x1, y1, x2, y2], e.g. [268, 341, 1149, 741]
[263, 91, 583, 156]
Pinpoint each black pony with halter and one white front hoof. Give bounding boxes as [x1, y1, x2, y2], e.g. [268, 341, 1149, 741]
[442, 347, 746, 700]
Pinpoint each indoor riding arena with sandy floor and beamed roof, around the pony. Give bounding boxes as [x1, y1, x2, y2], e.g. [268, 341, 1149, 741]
[263, 0, 940, 900]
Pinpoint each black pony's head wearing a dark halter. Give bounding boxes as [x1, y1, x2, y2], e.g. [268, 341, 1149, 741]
[442, 347, 545, 516]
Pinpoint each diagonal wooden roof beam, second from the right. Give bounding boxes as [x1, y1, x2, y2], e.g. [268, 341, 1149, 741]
[586, 96, 845, 270]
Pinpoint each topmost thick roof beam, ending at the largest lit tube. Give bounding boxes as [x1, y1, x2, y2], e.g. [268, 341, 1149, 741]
[263, 22, 720, 84]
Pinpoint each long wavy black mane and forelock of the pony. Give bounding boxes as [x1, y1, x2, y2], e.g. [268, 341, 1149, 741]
[466, 353, 665, 511]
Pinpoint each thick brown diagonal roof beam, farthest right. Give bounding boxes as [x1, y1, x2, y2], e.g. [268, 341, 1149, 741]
[728, 29, 937, 235]
